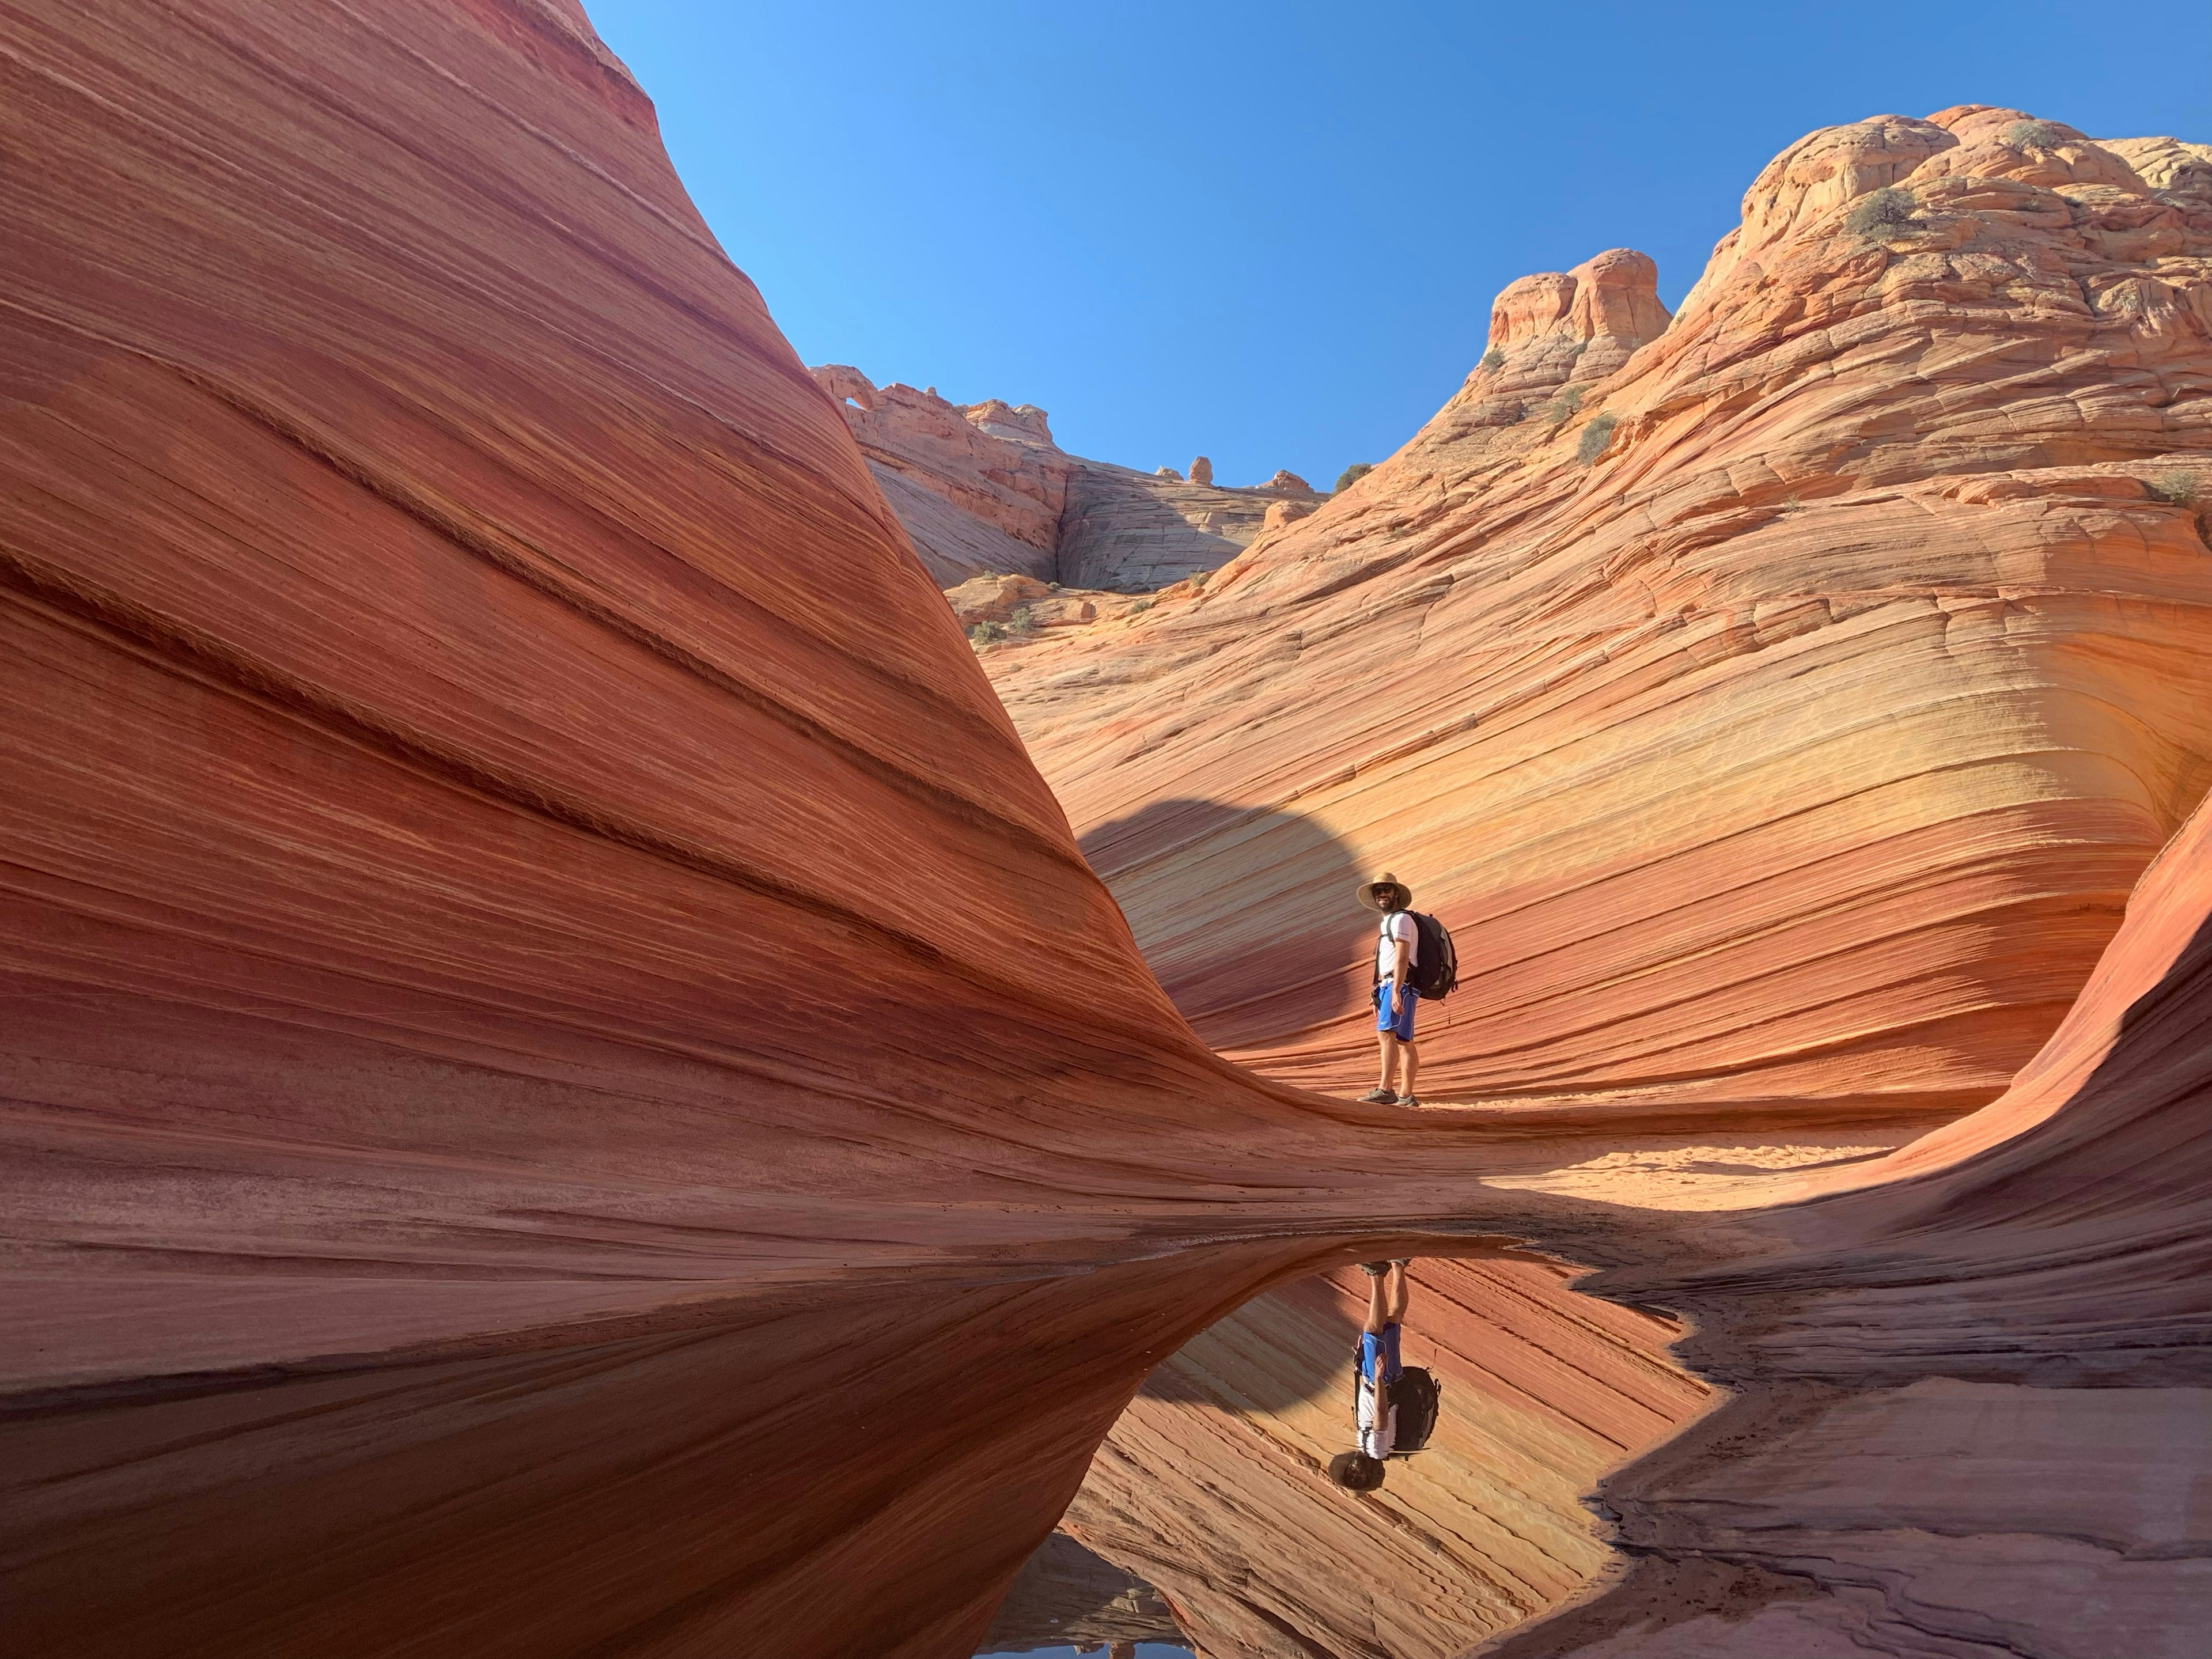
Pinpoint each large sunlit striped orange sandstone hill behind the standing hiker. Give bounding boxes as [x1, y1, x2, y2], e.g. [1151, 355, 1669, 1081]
[993, 108, 2212, 1113]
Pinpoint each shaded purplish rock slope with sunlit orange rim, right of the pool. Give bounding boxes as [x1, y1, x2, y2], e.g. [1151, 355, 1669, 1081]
[1484, 783, 2212, 1659]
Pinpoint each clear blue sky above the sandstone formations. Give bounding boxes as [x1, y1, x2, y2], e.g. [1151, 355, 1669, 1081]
[586, 0, 2212, 489]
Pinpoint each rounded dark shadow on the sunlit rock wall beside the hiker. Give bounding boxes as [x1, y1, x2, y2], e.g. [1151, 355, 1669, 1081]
[1082, 798, 1374, 1048]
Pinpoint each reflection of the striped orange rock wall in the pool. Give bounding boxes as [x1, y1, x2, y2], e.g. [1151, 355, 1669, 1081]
[1062, 1252, 1707, 1659]
